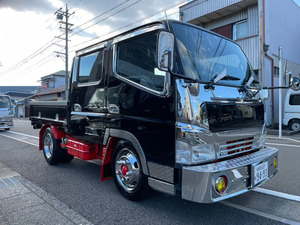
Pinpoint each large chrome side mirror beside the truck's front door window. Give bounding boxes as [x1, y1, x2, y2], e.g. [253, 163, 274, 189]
[157, 31, 175, 72]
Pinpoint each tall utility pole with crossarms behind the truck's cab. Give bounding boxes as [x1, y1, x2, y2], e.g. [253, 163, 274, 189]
[54, 4, 74, 100]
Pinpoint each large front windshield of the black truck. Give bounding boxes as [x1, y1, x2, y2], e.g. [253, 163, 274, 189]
[172, 23, 259, 88]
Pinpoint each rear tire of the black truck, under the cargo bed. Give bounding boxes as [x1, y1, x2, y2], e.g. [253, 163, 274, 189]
[43, 127, 63, 165]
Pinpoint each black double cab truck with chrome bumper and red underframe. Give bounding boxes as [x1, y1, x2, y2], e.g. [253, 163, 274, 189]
[30, 20, 284, 203]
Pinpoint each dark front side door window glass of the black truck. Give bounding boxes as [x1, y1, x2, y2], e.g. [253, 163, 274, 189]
[116, 32, 166, 92]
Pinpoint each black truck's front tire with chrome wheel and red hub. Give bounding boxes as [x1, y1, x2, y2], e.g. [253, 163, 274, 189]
[111, 141, 149, 201]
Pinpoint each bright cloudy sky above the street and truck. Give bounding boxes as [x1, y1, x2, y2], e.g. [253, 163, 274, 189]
[0, 0, 188, 86]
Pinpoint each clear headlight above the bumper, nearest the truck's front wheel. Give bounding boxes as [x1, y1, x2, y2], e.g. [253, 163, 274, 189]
[176, 125, 216, 165]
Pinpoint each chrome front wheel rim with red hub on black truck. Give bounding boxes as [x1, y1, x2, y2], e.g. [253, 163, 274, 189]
[115, 148, 142, 193]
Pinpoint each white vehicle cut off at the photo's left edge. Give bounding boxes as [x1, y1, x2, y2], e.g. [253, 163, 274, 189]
[0, 95, 14, 130]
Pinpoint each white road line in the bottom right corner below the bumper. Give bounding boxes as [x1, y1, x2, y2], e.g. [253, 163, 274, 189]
[220, 201, 300, 225]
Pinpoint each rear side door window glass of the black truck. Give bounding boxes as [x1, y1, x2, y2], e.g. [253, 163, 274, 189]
[78, 49, 103, 83]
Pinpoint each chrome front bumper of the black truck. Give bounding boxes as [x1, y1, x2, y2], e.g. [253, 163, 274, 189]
[181, 147, 278, 203]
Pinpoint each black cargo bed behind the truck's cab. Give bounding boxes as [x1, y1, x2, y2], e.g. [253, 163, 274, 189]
[30, 101, 68, 128]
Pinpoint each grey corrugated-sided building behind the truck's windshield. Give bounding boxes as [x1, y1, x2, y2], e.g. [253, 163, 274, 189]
[180, 0, 300, 125]
